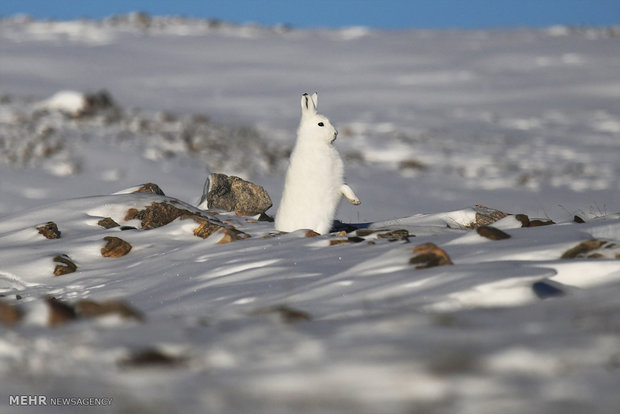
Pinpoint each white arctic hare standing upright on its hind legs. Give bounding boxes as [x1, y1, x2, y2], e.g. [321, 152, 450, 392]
[275, 93, 360, 234]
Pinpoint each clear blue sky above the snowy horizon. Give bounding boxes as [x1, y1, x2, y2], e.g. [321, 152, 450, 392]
[0, 0, 620, 29]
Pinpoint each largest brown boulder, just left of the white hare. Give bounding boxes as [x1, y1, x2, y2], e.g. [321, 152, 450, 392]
[200, 173, 273, 216]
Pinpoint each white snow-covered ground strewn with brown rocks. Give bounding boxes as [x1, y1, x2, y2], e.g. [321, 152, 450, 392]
[0, 15, 620, 413]
